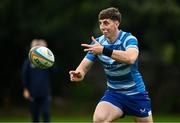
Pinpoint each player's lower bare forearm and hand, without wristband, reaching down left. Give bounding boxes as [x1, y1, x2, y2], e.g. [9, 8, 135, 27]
[69, 58, 93, 81]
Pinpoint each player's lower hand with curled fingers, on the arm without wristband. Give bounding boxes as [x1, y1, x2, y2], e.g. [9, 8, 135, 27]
[69, 71, 83, 82]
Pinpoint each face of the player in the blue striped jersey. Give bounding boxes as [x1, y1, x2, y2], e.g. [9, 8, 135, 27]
[99, 19, 119, 39]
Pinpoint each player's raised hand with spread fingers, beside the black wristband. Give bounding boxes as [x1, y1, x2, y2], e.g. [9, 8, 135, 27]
[81, 36, 103, 55]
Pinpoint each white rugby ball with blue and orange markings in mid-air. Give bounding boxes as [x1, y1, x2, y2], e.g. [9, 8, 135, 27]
[29, 46, 55, 69]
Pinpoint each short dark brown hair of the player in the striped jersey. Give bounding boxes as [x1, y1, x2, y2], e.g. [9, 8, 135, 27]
[99, 7, 121, 23]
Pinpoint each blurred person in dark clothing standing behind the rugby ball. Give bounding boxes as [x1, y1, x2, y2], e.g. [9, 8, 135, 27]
[22, 39, 55, 122]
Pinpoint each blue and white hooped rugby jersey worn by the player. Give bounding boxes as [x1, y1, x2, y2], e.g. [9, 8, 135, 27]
[85, 30, 146, 95]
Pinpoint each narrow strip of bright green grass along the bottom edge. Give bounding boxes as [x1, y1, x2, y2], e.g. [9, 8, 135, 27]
[0, 115, 180, 123]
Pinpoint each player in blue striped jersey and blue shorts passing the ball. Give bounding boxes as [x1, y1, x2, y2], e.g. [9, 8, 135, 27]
[69, 7, 153, 123]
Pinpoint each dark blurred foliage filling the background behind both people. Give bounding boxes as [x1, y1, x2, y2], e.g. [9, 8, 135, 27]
[0, 0, 180, 117]
